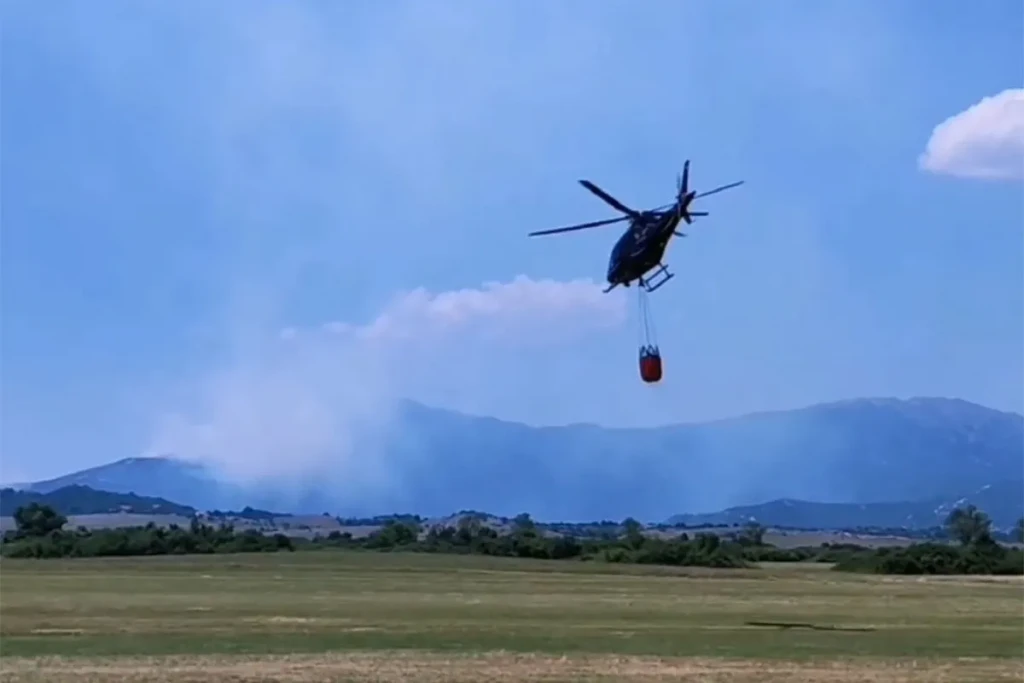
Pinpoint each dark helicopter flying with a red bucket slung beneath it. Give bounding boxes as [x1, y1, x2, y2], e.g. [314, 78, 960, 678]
[528, 159, 744, 294]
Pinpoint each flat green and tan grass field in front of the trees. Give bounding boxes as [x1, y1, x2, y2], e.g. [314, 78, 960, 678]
[0, 551, 1024, 683]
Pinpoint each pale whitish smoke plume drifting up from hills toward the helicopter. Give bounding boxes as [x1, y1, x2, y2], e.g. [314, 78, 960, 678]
[146, 275, 626, 496]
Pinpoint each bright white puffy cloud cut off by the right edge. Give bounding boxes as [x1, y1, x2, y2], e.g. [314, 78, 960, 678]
[919, 88, 1024, 180]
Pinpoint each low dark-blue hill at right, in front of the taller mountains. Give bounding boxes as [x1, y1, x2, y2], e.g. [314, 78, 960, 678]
[666, 480, 1024, 529]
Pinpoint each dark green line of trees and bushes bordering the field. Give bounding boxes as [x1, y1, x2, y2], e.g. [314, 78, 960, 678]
[2, 503, 1024, 574]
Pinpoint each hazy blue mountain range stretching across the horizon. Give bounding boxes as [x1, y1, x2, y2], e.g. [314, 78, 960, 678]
[9, 398, 1024, 526]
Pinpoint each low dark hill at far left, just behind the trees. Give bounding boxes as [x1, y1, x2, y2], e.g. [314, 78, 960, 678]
[0, 484, 196, 517]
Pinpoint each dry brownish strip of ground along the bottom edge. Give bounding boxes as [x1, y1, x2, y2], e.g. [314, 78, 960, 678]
[0, 651, 1024, 683]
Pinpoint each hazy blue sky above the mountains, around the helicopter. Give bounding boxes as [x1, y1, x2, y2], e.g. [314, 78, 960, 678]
[0, 0, 1024, 481]
